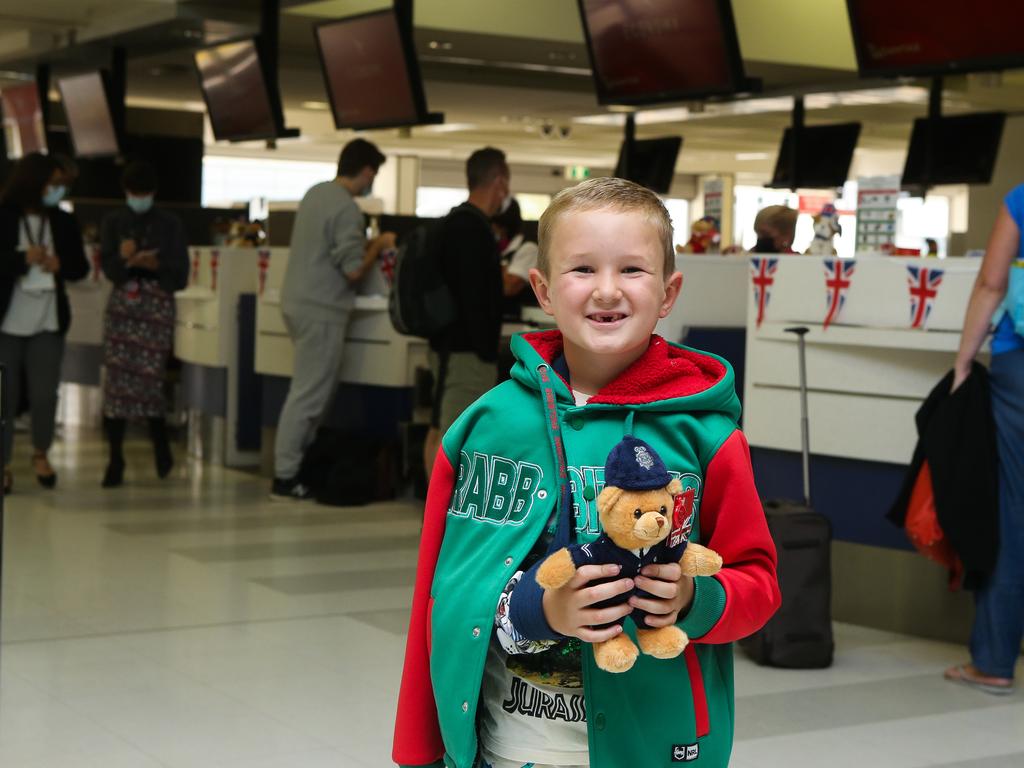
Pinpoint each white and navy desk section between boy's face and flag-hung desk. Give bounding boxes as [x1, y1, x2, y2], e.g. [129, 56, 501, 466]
[656, 259, 751, 397]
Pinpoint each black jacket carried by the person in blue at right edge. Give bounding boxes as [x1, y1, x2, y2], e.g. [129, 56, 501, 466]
[887, 362, 999, 589]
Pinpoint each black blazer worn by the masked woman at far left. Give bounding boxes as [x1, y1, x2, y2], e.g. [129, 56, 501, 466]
[0, 205, 89, 334]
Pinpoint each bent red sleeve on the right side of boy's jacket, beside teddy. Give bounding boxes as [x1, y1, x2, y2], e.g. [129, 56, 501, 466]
[700, 429, 782, 643]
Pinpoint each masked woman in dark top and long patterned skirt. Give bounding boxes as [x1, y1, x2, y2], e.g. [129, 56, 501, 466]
[100, 162, 188, 487]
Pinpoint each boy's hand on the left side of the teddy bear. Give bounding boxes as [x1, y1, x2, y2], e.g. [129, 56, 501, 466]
[543, 565, 633, 643]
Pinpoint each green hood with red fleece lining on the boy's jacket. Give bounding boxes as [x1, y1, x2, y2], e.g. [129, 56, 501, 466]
[512, 330, 740, 421]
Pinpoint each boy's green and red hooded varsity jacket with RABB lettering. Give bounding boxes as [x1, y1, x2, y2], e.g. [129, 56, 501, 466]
[393, 331, 780, 768]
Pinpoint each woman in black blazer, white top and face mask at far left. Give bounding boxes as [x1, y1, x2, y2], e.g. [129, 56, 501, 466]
[0, 153, 89, 494]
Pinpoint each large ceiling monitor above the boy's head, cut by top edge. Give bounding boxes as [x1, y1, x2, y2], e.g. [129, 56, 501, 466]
[578, 0, 746, 105]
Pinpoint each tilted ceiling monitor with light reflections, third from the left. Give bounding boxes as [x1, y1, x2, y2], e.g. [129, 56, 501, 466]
[194, 39, 284, 141]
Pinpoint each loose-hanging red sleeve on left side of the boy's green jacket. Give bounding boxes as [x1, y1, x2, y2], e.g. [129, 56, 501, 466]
[392, 450, 455, 765]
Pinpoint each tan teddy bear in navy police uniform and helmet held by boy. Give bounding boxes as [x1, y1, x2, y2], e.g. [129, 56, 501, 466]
[536, 435, 722, 672]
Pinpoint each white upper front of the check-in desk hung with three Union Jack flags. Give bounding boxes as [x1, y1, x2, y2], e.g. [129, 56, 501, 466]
[743, 256, 980, 463]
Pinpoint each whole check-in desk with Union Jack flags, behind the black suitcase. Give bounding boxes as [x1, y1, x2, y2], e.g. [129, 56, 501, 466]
[743, 255, 985, 640]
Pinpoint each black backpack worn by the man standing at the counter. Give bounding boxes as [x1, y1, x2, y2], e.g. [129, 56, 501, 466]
[388, 214, 456, 339]
